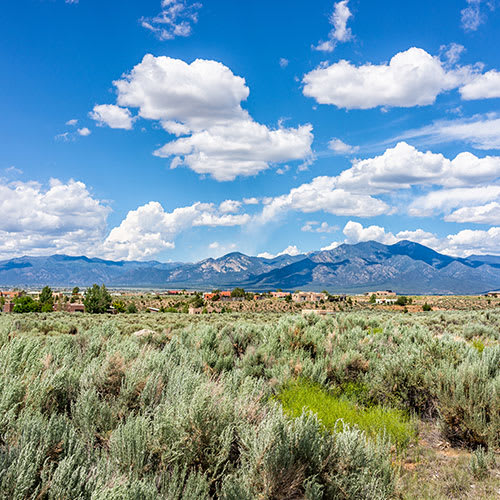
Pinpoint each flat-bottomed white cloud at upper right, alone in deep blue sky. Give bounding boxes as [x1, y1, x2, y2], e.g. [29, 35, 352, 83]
[303, 47, 480, 109]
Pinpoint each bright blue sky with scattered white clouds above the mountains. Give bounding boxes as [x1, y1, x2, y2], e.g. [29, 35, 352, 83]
[0, 0, 500, 261]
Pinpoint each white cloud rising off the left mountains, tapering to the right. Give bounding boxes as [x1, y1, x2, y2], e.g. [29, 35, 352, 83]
[102, 201, 250, 260]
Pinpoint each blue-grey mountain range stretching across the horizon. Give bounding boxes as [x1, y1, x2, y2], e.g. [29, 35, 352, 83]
[0, 241, 500, 294]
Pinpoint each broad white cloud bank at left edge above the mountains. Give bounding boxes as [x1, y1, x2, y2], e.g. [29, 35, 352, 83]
[0, 179, 110, 258]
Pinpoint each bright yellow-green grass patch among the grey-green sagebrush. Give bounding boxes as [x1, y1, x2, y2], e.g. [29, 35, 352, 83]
[277, 380, 416, 448]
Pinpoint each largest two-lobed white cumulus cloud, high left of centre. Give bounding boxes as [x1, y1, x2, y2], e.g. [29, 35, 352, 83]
[94, 54, 313, 181]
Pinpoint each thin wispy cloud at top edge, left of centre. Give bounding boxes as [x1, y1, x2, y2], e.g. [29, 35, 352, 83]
[141, 0, 202, 40]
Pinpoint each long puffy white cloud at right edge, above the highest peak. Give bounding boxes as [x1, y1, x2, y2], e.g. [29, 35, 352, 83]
[337, 142, 500, 194]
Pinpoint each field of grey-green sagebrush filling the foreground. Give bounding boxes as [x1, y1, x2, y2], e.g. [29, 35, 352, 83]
[0, 310, 500, 499]
